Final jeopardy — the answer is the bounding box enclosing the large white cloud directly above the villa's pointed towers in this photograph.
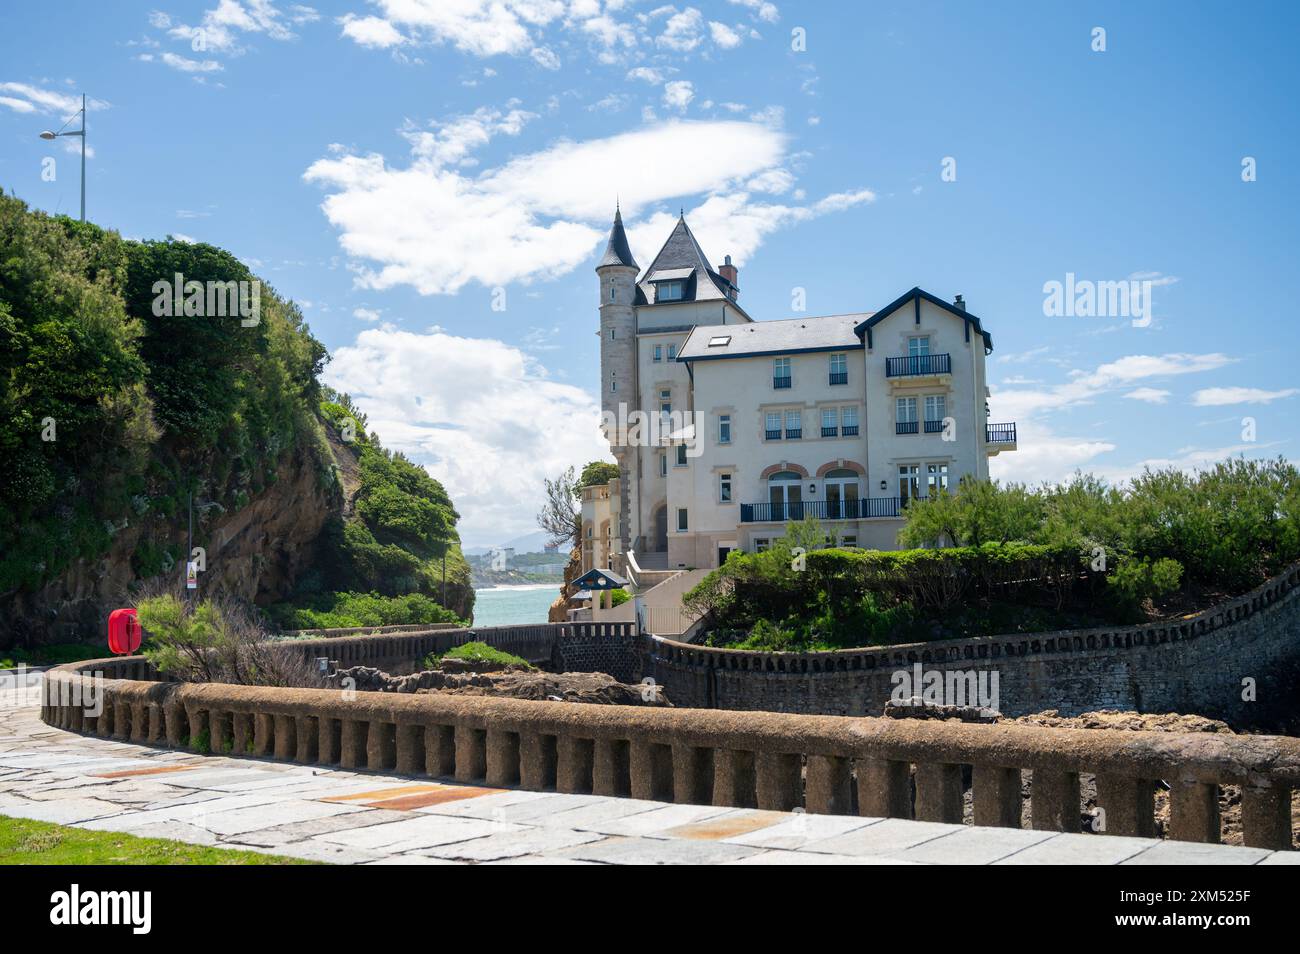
[304,110,875,294]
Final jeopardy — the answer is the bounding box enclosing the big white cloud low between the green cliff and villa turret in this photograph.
[324,328,608,546]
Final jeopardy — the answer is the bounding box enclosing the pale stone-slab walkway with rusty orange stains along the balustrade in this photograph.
[0,689,1300,864]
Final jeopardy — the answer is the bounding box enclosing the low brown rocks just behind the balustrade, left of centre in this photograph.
[326,665,672,706]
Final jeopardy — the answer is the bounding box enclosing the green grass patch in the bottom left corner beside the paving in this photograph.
[0,815,313,864]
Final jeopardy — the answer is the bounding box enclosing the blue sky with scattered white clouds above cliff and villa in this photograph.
[0,0,1300,545]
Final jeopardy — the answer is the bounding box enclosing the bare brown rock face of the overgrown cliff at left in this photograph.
[0,448,330,645]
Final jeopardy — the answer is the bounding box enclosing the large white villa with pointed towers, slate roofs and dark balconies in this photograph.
[582,212,1015,572]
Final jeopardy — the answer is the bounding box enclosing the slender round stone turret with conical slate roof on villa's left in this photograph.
[595,207,641,561]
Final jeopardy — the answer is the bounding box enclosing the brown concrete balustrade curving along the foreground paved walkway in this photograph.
[42,660,1300,849]
